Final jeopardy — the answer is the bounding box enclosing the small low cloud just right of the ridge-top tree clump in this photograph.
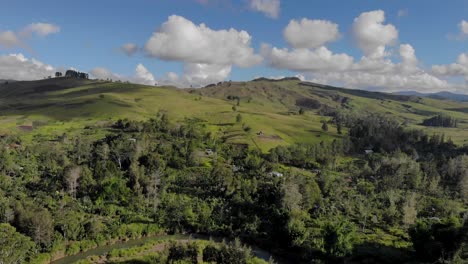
[91,63,156,85]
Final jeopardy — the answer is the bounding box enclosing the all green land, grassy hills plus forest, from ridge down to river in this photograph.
[0,79,468,263]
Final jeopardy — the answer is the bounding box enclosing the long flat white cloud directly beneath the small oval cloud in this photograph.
[262,44,353,71]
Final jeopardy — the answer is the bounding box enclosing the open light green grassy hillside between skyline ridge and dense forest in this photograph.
[0,78,468,151]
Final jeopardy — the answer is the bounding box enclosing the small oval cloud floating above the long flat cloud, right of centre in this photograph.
[283,18,340,48]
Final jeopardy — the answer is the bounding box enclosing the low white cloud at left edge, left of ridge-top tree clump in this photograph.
[0,53,55,81]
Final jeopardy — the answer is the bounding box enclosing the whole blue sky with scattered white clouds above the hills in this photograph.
[0,0,468,93]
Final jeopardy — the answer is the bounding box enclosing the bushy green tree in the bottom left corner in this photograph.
[0,224,35,264]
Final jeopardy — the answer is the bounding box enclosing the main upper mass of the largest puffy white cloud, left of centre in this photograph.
[145,15,261,67]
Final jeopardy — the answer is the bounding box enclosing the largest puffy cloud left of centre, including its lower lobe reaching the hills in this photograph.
[145,15,262,87]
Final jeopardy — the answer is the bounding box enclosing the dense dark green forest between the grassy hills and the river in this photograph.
[0,112,468,263]
